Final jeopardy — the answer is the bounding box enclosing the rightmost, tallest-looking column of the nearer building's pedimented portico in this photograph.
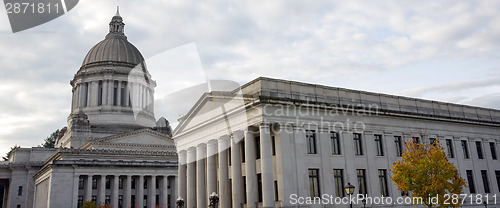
[259,123,274,207]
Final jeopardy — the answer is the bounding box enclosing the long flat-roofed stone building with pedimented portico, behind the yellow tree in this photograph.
[174,78,500,208]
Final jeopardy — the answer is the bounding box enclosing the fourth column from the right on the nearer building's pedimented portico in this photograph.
[218,135,231,208]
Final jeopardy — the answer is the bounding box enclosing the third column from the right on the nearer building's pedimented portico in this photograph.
[231,131,243,207]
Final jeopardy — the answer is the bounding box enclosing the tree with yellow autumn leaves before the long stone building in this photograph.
[391,141,466,208]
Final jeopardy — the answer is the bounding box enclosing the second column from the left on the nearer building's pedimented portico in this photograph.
[185,147,196,207]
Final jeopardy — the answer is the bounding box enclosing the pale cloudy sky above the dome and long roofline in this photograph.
[0,0,500,155]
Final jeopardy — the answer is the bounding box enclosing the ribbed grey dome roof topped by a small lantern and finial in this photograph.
[82,12,144,67]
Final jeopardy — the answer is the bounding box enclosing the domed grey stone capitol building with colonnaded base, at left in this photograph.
[0,11,177,208]
